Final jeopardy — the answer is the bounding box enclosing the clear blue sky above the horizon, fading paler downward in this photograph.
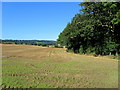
[2,2,81,40]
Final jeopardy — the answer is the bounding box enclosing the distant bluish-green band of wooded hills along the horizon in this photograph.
[0,40,57,46]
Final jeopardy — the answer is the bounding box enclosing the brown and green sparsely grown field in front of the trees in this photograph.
[2,44,118,88]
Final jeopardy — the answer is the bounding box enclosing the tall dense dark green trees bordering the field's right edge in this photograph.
[57,1,120,56]
